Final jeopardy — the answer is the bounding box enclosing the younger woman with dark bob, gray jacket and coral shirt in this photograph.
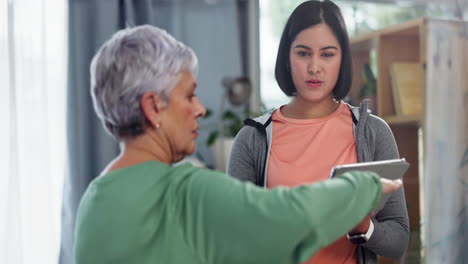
[227,1,409,264]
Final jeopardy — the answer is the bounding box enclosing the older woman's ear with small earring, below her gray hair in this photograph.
[140,92,166,128]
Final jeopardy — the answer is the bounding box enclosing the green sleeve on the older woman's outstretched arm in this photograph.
[177,169,382,264]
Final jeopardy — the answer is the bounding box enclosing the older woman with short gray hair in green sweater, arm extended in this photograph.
[75,25,401,264]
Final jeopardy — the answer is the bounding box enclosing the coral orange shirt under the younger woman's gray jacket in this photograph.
[267,102,357,264]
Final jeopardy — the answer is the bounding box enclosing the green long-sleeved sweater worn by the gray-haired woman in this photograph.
[75,161,382,264]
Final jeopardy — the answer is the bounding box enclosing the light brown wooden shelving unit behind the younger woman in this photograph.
[350,18,466,263]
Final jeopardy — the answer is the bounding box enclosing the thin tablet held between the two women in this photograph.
[330,158,410,211]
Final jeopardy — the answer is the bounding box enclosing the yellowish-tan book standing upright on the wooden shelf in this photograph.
[390,62,424,115]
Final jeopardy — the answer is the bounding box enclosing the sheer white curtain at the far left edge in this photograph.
[0,0,66,264]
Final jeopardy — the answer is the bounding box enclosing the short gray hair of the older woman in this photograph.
[90,25,198,140]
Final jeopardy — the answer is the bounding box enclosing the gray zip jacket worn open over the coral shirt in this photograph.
[227,101,409,264]
